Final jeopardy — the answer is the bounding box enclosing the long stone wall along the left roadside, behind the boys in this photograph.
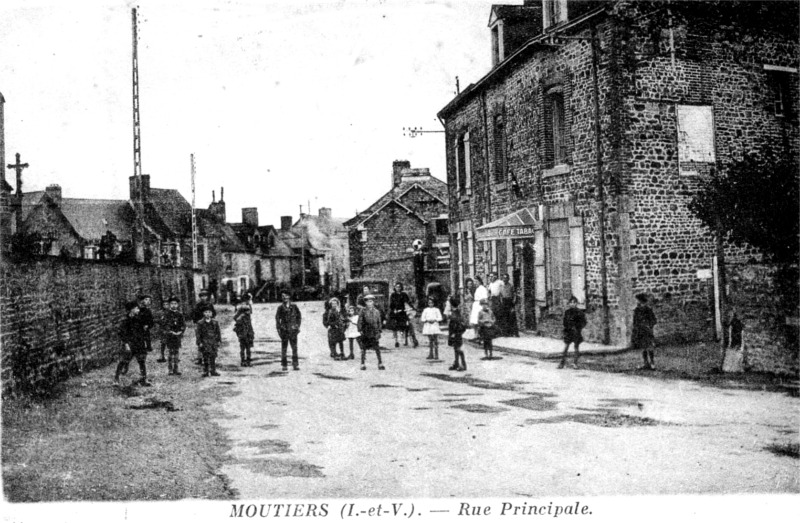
[0,258,194,395]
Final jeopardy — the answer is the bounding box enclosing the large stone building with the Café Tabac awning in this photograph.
[440,0,799,345]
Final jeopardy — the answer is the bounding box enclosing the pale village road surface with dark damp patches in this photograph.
[208,302,800,499]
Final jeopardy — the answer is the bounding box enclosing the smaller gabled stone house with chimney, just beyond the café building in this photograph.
[344,160,450,304]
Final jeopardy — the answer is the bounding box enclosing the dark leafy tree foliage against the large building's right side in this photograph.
[689,149,800,265]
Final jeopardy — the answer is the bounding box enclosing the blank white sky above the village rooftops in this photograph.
[0,0,500,225]
